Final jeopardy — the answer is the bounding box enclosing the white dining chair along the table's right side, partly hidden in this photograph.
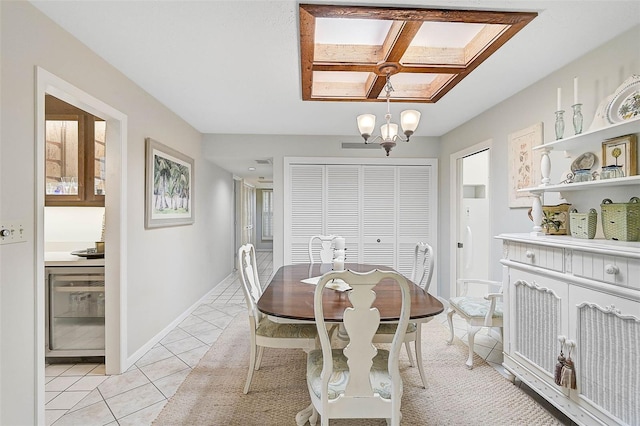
[373,242,434,388]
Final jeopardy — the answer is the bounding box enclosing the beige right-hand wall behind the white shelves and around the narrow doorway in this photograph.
[439,26,640,295]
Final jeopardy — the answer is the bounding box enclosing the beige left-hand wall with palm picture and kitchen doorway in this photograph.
[0,1,233,425]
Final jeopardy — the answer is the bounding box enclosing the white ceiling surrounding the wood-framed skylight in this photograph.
[31,0,640,182]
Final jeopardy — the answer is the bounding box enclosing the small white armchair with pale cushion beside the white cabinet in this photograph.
[447,278,503,369]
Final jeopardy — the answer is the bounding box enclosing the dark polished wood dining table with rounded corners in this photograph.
[257,263,444,426]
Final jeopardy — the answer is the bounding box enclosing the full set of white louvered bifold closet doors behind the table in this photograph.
[285,163,437,276]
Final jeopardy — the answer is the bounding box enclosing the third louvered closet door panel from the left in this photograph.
[361,166,397,268]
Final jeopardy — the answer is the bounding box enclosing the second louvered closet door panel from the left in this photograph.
[325,165,362,262]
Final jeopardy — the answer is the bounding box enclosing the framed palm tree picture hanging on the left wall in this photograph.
[144,138,195,229]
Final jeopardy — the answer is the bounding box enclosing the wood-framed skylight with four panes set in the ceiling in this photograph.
[300,4,537,103]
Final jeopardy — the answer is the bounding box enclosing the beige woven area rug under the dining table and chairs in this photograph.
[153,313,561,426]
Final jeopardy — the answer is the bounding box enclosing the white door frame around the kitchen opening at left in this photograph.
[34,67,128,424]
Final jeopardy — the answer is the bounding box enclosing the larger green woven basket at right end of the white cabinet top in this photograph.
[600,197,640,241]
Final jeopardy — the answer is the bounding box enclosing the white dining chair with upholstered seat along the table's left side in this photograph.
[238,244,318,394]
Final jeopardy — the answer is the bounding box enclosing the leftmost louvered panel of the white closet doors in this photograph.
[285,165,325,264]
